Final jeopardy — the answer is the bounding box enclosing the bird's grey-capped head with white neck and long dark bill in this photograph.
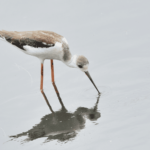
[67,55,100,94]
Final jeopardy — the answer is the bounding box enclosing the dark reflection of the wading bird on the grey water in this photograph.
[10,96,101,142]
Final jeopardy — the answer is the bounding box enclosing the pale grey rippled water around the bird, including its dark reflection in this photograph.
[0,0,150,150]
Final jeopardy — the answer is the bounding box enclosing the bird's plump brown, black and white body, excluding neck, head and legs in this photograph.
[0,30,71,61]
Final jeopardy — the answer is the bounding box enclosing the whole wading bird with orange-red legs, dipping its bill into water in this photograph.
[0,30,100,109]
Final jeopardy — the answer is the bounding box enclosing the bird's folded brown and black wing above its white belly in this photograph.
[0,30,62,50]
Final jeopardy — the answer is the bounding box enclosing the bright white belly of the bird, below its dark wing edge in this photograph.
[24,43,63,60]
